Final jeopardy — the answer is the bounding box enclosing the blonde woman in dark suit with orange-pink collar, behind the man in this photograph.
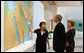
[66,20,75,52]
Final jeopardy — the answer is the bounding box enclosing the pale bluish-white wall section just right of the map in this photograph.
[33,1,45,41]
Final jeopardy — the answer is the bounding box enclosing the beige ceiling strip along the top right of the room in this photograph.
[41,1,83,7]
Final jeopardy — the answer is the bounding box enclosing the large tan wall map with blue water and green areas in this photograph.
[4,1,33,51]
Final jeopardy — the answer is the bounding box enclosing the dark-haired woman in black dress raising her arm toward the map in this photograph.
[27,20,50,52]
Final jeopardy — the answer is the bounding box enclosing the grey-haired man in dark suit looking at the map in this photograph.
[50,15,66,52]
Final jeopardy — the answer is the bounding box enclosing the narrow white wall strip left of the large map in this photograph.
[1,1,4,51]
